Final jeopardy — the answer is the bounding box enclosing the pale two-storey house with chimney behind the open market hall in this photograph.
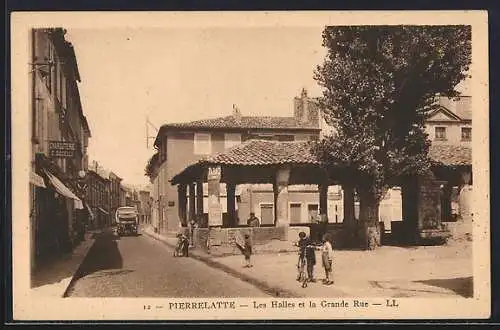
[146,90,320,233]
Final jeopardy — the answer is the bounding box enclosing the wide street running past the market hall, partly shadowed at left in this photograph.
[68,232,266,297]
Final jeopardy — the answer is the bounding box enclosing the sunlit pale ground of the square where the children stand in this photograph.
[144,228,472,298]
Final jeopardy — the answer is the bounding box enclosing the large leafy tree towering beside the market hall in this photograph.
[314,26,471,248]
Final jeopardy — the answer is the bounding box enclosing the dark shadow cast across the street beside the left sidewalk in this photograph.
[74,231,123,281]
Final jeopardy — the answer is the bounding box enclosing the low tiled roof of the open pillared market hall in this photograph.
[199,140,319,166]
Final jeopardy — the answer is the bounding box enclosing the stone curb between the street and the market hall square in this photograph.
[143,230,307,298]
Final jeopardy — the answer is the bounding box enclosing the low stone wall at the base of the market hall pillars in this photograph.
[193,227,309,256]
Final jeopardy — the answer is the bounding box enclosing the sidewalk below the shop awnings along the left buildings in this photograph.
[31,230,101,297]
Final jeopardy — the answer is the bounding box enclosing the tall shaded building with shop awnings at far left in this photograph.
[30,28,91,269]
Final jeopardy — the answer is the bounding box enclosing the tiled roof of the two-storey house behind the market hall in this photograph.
[162,116,319,130]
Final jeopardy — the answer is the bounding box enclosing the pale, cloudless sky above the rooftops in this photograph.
[66,26,326,185]
